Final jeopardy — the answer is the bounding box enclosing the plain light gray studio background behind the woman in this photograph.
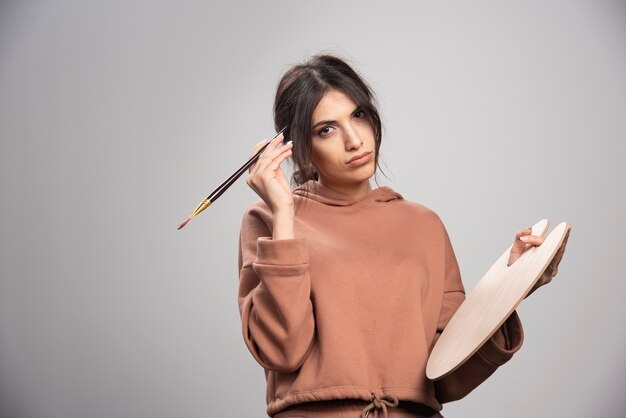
[0,0,626,418]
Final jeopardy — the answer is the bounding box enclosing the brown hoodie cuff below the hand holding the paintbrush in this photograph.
[255,237,309,266]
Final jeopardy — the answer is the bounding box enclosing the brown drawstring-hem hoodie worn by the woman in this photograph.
[239,180,523,416]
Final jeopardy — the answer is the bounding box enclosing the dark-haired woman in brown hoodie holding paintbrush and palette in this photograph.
[238,55,569,418]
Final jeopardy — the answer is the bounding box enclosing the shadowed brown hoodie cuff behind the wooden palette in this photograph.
[478,311,524,366]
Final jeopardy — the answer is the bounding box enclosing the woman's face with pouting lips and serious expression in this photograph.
[311,90,376,190]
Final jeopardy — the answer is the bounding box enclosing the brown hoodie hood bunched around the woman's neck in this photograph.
[293,180,404,206]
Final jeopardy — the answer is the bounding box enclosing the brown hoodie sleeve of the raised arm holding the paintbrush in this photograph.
[238,206,315,373]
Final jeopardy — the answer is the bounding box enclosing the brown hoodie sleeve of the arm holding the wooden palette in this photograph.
[431,220,524,403]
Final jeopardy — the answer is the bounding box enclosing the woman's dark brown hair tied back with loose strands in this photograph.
[274,54,384,189]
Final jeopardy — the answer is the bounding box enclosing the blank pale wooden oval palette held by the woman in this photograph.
[426,219,568,380]
